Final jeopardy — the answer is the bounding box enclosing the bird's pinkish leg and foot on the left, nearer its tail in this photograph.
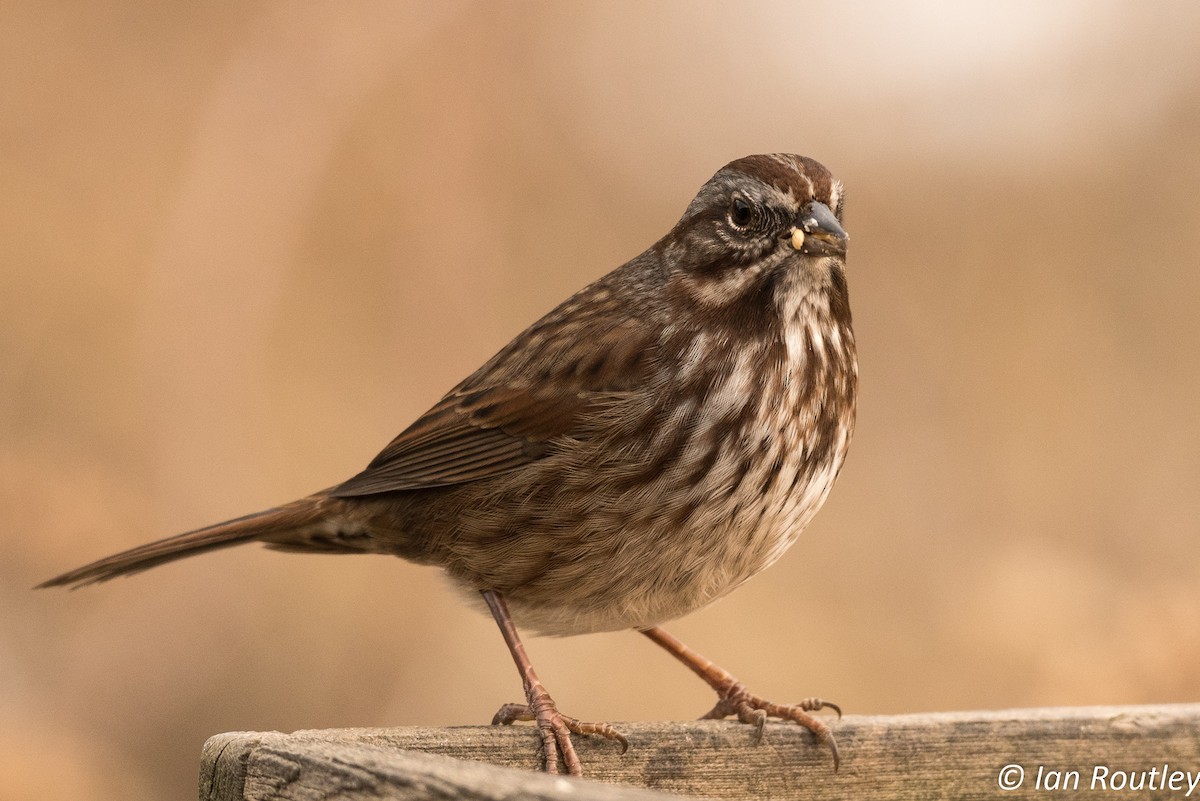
[482,590,629,776]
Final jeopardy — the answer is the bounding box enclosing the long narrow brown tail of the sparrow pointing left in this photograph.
[35,495,326,589]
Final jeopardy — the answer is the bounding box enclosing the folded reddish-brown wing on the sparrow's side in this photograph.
[331,320,650,498]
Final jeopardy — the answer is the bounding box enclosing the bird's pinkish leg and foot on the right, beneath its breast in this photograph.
[640,626,841,771]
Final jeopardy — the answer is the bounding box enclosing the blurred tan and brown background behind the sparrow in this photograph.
[0,0,1200,801]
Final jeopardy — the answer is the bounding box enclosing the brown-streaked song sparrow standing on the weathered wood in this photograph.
[41,155,858,773]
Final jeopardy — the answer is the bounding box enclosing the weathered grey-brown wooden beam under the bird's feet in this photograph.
[200,704,1200,801]
